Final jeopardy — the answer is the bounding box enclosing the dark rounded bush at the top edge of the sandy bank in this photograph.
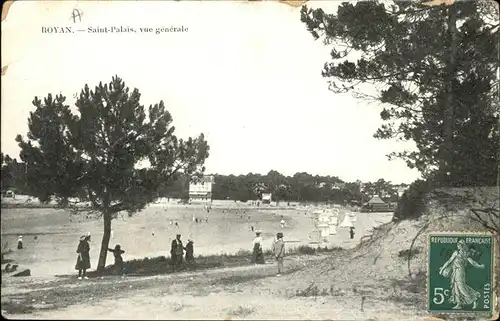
[392,180,430,222]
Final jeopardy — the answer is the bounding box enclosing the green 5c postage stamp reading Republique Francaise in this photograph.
[427,232,496,317]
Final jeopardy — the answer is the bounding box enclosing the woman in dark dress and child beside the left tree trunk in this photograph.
[75,232,125,280]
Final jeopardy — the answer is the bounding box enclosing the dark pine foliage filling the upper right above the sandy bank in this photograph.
[301,0,499,186]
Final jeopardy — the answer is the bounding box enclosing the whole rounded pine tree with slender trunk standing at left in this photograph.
[16,76,209,269]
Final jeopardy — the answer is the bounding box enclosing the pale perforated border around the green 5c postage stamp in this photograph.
[425,231,499,320]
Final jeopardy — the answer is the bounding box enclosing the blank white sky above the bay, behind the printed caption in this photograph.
[1,1,420,183]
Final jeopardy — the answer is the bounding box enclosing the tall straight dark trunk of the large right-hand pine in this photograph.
[439,4,458,183]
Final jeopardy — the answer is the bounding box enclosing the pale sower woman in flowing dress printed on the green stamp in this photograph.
[439,240,484,309]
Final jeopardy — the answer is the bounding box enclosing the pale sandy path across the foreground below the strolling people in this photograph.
[2,256,422,320]
